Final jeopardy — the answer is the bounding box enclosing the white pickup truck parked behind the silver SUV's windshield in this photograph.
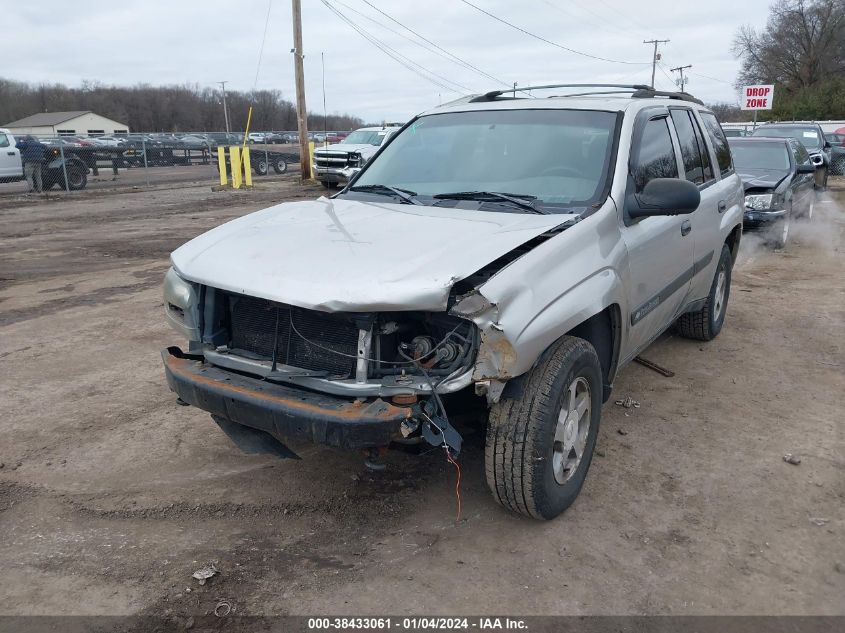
[314,125,400,188]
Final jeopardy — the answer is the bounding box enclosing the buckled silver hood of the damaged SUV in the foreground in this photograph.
[171,198,574,312]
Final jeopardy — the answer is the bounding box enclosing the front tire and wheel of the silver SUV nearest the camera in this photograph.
[485,336,602,520]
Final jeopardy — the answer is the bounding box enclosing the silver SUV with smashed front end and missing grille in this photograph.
[162,85,743,519]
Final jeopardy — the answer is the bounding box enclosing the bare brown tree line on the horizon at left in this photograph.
[0,78,364,132]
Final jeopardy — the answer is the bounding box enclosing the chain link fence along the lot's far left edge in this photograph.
[0,130,310,197]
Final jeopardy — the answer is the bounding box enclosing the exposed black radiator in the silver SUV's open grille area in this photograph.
[228,295,358,378]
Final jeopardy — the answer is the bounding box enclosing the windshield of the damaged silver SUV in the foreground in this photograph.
[355,109,616,210]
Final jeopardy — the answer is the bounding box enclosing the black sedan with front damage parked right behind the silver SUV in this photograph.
[728,137,817,248]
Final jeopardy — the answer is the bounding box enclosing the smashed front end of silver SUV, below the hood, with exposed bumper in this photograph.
[164,269,492,454]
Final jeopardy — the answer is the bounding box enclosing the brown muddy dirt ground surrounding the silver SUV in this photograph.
[0,174,845,617]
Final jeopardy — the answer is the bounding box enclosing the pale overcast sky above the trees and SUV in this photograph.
[8,0,770,121]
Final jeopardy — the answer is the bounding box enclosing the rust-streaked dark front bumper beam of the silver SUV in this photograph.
[161,347,411,449]
